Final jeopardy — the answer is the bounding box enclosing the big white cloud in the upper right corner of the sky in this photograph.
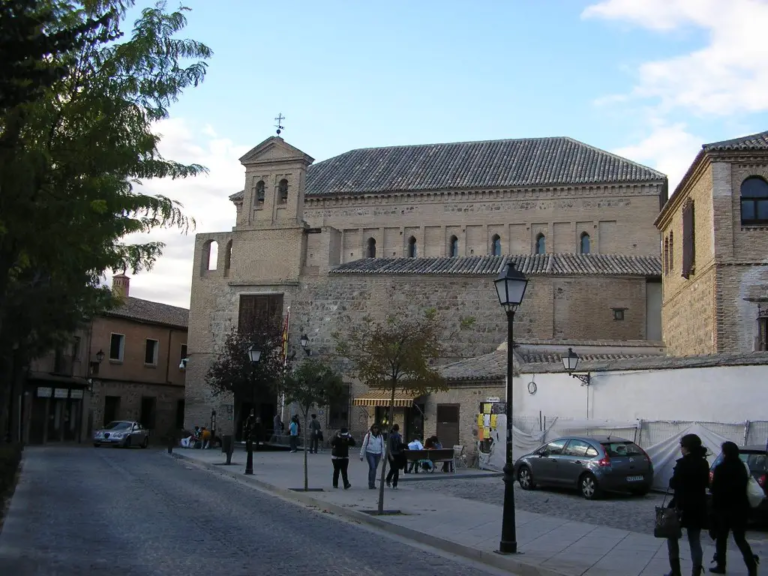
[582,0,768,116]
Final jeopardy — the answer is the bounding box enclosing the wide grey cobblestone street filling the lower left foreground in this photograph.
[0,447,510,576]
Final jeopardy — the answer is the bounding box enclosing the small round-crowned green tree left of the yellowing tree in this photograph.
[281,359,344,491]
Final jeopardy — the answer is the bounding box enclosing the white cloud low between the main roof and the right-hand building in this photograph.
[613,122,701,189]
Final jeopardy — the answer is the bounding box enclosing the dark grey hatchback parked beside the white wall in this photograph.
[515,436,653,500]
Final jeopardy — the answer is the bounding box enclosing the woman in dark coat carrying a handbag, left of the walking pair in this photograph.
[667,434,709,576]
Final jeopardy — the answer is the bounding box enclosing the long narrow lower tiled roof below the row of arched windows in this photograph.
[331,254,661,276]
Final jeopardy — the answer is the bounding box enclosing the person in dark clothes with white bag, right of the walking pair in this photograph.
[710,442,757,576]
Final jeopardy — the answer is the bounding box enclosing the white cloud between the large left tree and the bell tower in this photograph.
[107,118,249,307]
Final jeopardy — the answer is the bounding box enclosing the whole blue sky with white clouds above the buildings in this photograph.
[114,0,768,307]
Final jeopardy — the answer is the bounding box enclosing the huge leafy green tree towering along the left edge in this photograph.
[0,0,211,438]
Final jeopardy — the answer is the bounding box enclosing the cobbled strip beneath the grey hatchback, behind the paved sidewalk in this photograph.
[416,478,768,542]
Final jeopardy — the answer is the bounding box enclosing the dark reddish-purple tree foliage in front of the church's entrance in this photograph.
[205,319,290,403]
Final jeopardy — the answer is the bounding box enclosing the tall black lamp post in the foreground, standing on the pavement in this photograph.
[494,261,528,554]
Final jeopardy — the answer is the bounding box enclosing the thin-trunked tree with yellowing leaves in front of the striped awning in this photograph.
[334,310,464,514]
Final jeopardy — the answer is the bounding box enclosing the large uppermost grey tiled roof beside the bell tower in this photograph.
[230,137,667,201]
